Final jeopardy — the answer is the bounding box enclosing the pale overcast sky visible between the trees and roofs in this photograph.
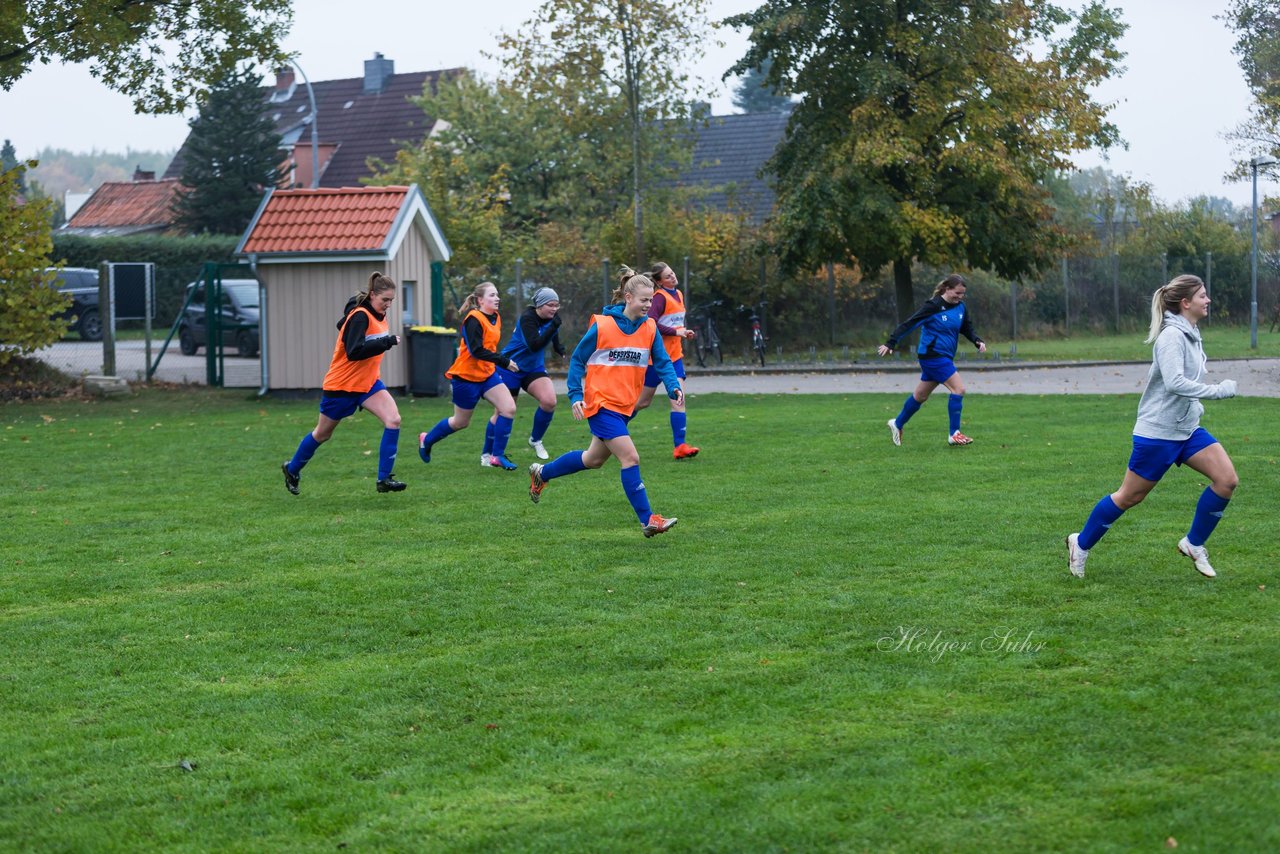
[0,0,1276,205]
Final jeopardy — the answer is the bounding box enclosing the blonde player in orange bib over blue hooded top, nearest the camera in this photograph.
[529,266,684,536]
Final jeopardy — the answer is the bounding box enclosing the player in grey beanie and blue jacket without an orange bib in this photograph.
[480,288,564,467]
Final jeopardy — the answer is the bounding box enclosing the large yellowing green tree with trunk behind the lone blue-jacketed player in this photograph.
[726,0,1124,316]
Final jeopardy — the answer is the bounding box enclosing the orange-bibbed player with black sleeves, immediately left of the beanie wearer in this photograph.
[417,282,520,471]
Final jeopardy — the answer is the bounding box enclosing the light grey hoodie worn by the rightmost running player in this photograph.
[1133,311,1235,442]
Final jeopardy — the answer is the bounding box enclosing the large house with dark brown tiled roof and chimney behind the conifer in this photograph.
[165,54,461,187]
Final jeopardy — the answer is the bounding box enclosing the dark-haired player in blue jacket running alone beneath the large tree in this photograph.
[877,273,987,446]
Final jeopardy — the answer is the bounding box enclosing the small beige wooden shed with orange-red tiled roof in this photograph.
[236,184,449,389]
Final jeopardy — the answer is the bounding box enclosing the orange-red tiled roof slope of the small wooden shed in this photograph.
[239,187,408,255]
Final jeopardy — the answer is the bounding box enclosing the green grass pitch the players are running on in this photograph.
[0,391,1280,851]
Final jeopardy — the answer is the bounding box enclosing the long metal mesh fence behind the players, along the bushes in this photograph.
[444,254,1280,361]
